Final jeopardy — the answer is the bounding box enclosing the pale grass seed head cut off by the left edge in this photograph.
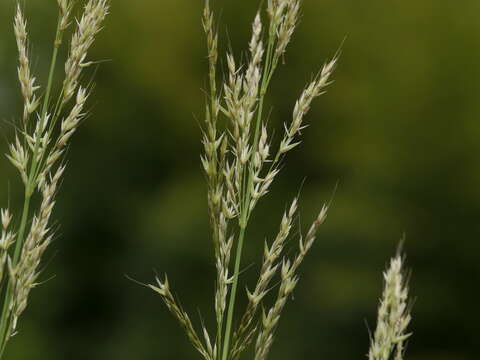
[0,0,109,358]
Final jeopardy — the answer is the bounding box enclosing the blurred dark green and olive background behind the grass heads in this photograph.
[0,0,480,360]
